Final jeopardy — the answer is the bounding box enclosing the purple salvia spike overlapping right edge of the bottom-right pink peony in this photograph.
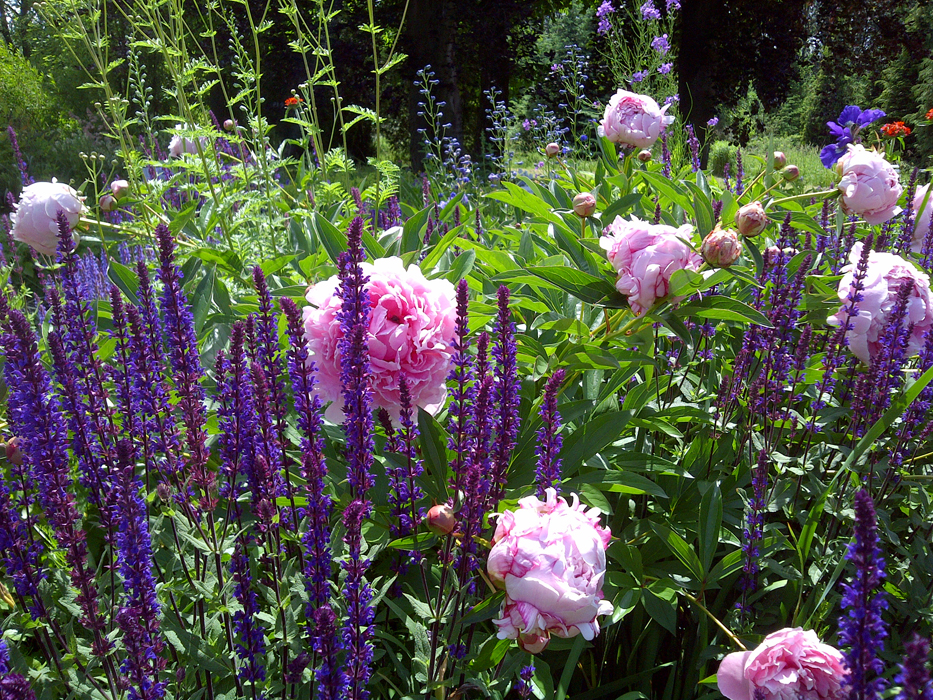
[839,489,888,700]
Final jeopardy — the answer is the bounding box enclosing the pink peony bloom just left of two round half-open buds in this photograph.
[599,216,703,315]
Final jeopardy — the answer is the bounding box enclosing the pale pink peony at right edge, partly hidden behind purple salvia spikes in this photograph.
[827,241,933,364]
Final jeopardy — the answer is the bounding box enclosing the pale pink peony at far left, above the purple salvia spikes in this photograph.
[11,181,84,255]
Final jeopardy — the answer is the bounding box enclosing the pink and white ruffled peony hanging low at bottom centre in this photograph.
[486,488,612,654]
